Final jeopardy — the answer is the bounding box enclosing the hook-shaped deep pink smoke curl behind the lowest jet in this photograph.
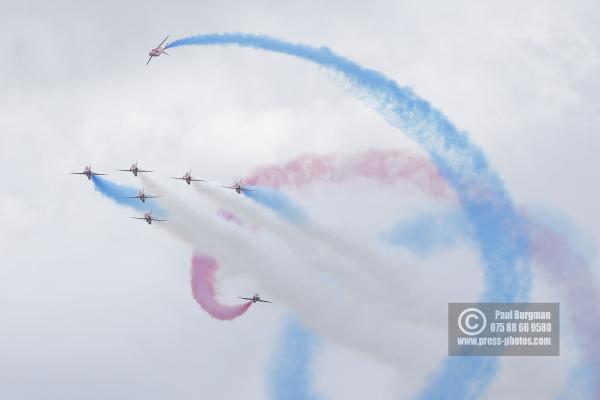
[192,254,252,321]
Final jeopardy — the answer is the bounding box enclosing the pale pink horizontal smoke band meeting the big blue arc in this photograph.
[245,150,454,198]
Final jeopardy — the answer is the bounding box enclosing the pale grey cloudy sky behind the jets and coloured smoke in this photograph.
[0,1,600,399]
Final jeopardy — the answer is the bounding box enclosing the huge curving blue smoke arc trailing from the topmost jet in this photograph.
[167,33,531,399]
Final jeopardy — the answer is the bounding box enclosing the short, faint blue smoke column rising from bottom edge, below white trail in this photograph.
[269,317,318,400]
